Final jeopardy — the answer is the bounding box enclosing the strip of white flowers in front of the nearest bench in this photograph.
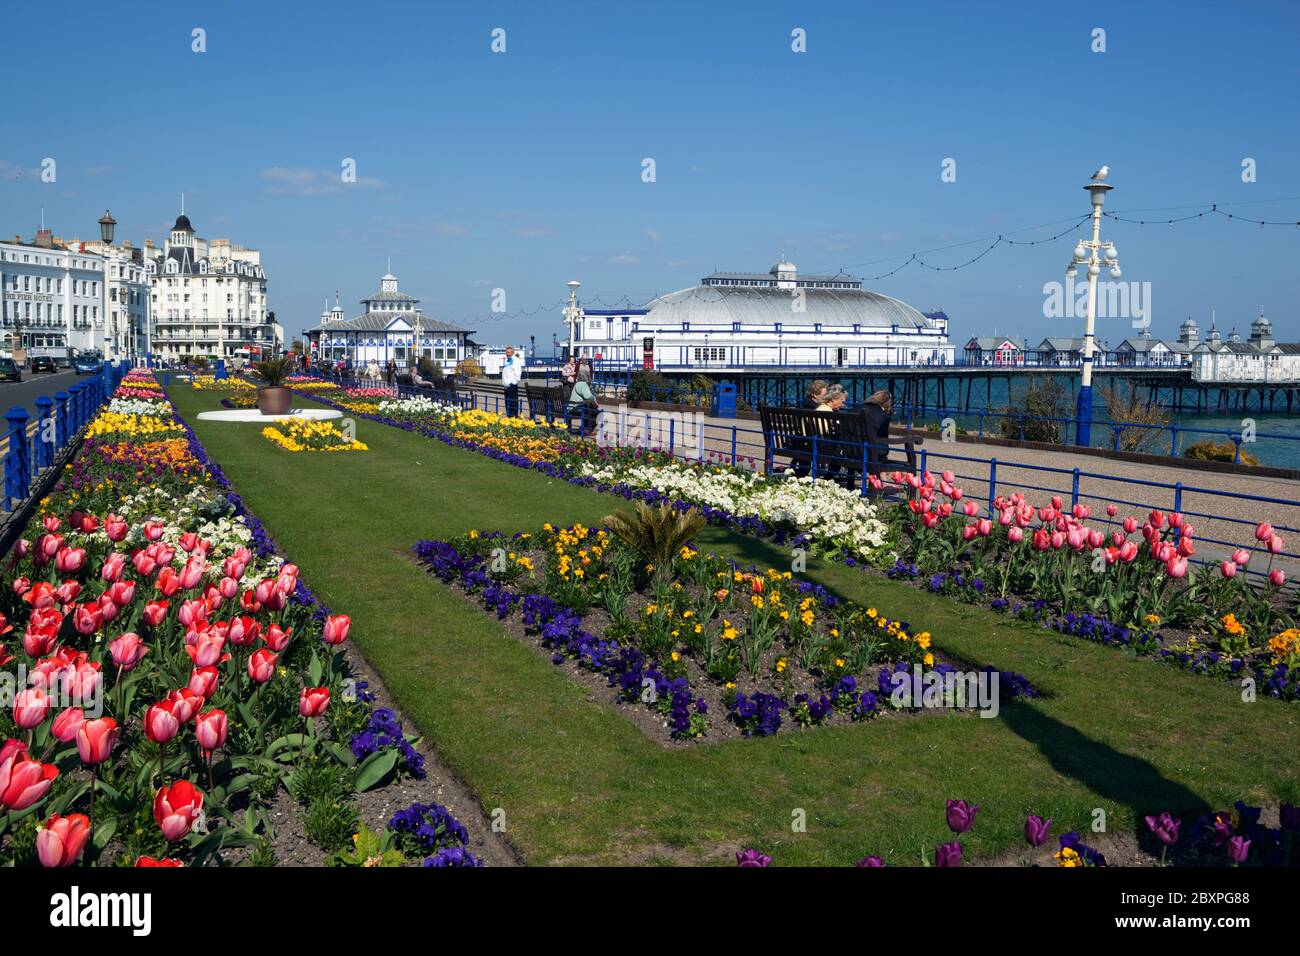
[580,463,888,561]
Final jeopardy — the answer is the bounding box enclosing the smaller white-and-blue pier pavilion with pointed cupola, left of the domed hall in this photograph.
[304,272,472,372]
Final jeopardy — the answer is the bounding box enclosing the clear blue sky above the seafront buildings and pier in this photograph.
[0,0,1300,346]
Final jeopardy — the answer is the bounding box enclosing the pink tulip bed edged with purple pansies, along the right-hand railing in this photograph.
[888,473,1300,700]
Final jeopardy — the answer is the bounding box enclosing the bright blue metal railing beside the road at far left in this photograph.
[3,362,127,512]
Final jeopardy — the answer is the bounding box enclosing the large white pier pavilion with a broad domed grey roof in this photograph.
[564,259,954,371]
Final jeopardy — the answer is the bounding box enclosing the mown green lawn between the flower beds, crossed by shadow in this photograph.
[173,385,1300,865]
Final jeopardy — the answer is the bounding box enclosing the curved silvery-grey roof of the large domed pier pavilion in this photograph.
[642,283,936,332]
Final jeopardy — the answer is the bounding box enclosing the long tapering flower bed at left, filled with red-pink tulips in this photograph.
[0,372,452,866]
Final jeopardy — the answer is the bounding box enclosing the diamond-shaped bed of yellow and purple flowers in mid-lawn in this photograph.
[415,524,1035,740]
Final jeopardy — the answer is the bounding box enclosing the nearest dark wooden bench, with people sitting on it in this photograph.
[758,405,924,492]
